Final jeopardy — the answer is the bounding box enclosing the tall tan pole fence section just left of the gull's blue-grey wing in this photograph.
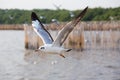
[24,26,43,49]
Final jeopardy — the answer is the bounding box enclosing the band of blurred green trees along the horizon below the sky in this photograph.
[0,7,120,24]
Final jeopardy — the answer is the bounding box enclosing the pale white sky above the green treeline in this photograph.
[0,0,120,10]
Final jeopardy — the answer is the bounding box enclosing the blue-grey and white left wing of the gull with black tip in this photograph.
[31,12,53,44]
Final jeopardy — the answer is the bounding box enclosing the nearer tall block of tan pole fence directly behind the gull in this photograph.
[24,22,84,50]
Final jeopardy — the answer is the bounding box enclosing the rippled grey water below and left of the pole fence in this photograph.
[0,31,120,80]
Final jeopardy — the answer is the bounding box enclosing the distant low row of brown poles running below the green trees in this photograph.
[0,21,120,31]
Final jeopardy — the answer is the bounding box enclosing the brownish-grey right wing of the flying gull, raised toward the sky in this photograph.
[53,7,88,46]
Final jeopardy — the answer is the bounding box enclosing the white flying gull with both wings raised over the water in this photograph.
[31,7,88,58]
